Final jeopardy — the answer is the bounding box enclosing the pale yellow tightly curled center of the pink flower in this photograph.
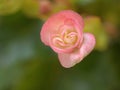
[53,30,78,49]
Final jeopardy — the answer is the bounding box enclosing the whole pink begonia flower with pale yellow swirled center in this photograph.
[40,10,95,68]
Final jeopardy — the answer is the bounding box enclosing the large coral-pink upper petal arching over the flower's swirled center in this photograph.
[40,10,84,45]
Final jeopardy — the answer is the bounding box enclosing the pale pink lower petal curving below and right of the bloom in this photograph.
[58,33,95,68]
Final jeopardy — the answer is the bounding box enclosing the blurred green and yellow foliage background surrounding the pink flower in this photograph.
[0,0,120,90]
